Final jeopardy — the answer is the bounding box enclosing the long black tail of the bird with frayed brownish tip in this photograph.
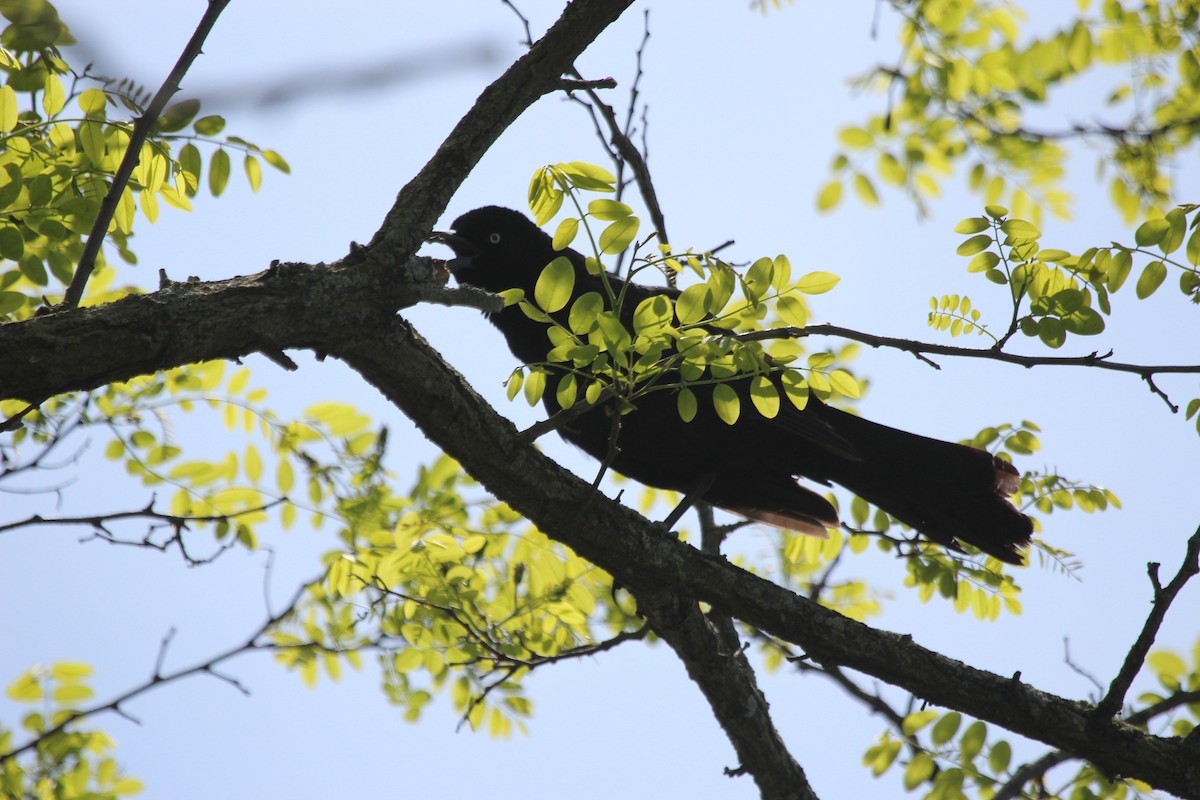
[811,405,1033,564]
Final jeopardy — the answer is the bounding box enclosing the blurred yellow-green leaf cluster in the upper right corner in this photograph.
[817,0,1200,223]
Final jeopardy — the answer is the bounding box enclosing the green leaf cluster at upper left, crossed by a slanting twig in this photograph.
[0,9,289,319]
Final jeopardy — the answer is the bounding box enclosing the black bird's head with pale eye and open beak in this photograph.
[430,205,556,291]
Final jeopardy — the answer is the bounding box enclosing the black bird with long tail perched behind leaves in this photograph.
[431,206,1032,564]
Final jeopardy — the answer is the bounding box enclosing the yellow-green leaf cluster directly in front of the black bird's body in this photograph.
[520,162,862,425]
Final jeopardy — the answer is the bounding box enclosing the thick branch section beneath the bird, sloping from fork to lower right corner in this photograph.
[330,319,1200,798]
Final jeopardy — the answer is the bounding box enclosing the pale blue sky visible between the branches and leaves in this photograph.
[0,0,1200,800]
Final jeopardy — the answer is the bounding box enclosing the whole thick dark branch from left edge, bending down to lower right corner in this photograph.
[0,253,1200,798]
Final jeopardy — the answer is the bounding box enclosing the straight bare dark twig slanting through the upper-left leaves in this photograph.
[59,0,229,309]
